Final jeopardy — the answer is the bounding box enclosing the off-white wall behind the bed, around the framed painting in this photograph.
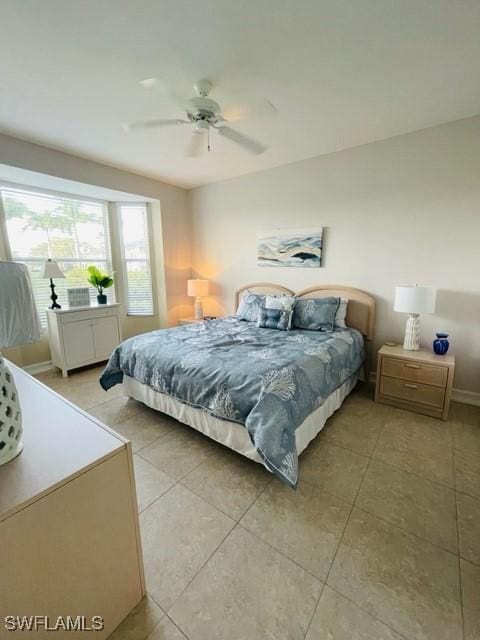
[190,117,480,392]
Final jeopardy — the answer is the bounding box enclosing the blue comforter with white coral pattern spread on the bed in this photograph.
[100,318,364,487]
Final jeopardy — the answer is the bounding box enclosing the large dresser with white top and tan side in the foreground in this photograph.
[0,363,145,640]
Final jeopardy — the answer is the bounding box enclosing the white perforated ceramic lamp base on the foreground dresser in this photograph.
[0,355,23,466]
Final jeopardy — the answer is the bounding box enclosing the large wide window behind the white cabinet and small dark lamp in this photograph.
[0,187,113,326]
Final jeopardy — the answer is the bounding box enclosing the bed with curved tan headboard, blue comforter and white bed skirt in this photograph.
[100,283,375,487]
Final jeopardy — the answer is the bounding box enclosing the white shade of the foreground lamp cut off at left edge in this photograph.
[0,261,41,348]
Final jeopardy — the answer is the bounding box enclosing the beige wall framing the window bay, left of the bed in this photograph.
[0,134,192,366]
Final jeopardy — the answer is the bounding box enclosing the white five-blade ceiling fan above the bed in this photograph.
[124,80,276,156]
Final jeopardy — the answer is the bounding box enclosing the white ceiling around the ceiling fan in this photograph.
[0,0,480,187]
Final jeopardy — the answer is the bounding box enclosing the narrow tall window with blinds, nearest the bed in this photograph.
[118,203,153,316]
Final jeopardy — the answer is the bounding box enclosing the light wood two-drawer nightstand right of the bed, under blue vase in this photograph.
[375,345,455,420]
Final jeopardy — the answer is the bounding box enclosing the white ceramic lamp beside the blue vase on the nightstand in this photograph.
[393,285,437,351]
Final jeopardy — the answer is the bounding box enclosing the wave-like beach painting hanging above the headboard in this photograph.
[257,227,323,267]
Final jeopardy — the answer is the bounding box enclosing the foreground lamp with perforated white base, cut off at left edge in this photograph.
[0,261,41,465]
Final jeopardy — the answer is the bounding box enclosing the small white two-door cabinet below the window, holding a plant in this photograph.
[47,304,122,378]
